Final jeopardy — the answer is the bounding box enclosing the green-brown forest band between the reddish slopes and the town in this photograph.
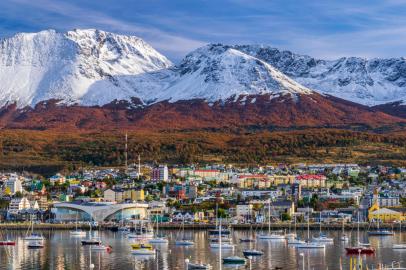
[0,129,406,173]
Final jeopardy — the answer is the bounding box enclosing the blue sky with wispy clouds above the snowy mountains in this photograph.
[0,0,406,62]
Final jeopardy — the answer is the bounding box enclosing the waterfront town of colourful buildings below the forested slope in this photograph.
[0,163,406,229]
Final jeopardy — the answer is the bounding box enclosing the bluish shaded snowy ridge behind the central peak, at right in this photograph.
[234,45,406,106]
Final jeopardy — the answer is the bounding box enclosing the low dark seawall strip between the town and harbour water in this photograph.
[0,223,399,231]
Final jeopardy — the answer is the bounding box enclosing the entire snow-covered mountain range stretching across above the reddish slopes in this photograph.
[0,29,406,108]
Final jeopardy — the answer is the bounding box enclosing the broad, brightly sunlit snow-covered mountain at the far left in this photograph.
[0,29,172,107]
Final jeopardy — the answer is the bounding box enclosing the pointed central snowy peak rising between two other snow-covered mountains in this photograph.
[128,45,313,102]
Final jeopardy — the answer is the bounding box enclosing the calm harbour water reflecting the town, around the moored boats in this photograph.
[0,231,406,270]
